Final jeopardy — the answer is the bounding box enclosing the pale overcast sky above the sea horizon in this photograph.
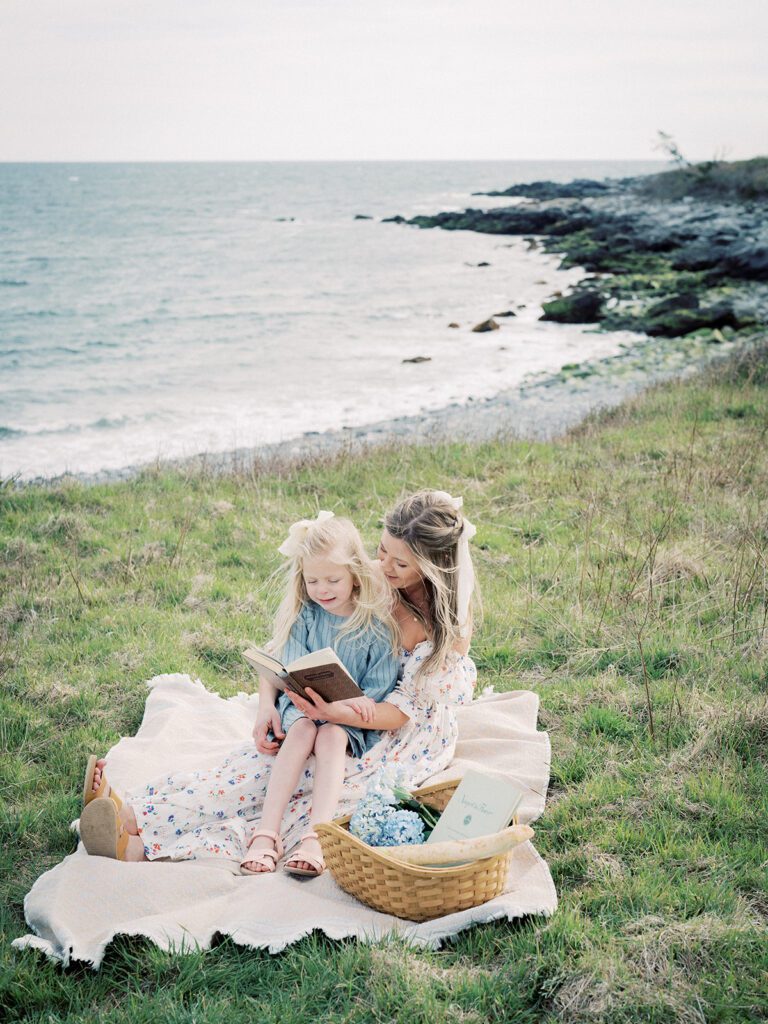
[0,0,768,161]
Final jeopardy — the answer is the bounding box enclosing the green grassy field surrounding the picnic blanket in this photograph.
[0,350,768,1024]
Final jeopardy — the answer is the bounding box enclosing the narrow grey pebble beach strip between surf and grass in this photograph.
[34,327,744,486]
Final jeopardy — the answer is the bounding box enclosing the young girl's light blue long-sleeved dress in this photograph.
[278,602,398,758]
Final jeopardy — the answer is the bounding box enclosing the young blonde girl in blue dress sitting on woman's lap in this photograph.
[241,512,397,876]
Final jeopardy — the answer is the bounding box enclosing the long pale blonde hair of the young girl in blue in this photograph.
[270,516,397,652]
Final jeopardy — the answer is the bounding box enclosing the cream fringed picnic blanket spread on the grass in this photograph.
[13,675,557,968]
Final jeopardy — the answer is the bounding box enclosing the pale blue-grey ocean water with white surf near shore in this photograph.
[0,161,659,479]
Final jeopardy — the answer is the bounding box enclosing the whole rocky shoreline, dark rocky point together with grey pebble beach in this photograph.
[18,160,768,486]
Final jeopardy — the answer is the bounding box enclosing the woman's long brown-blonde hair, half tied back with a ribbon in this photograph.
[384,490,477,675]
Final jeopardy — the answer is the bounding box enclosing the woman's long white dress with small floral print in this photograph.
[126,640,477,863]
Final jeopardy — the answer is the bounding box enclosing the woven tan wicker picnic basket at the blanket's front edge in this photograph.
[315,779,520,921]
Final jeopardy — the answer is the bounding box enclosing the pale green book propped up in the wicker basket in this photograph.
[427,770,522,843]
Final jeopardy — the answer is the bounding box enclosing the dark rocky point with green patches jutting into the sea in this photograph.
[386,158,768,342]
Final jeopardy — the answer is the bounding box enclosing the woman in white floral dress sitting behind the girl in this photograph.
[83,490,476,873]
